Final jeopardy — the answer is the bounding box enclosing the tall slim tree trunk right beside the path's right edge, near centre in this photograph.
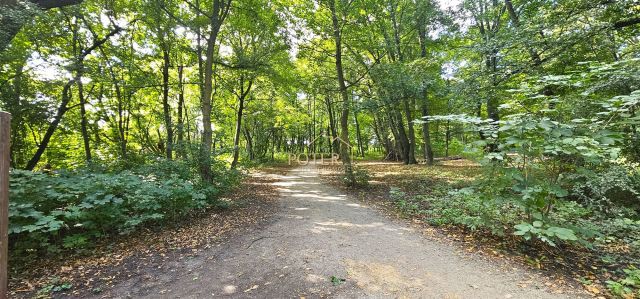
[329,0,356,185]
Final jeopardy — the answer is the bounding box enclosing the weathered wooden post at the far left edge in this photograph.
[0,111,11,299]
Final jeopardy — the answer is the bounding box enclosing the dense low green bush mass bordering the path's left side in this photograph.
[9,161,239,252]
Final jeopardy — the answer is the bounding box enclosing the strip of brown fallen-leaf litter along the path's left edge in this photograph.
[9,168,284,298]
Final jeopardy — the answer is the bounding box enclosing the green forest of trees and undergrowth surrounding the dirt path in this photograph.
[0,0,640,298]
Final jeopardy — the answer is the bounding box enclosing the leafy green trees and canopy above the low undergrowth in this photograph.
[0,0,640,296]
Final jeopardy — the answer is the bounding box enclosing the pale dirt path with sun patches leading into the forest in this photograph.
[99,166,575,298]
